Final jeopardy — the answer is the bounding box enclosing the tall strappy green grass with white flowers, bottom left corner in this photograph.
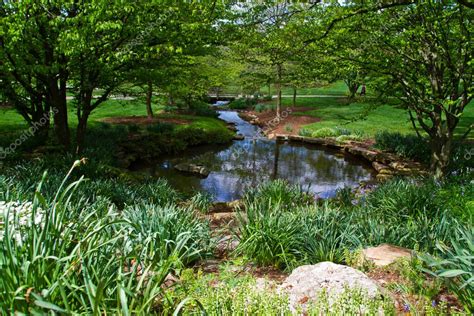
[0,164,210,315]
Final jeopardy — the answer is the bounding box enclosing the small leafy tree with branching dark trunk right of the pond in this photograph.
[320,1,474,178]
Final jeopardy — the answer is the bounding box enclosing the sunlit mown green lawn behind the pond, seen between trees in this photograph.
[0,93,474,139]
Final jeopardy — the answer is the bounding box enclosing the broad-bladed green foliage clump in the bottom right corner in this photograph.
[421,227,474,313]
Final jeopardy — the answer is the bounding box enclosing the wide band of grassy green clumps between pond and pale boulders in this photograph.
[237,180,466,269]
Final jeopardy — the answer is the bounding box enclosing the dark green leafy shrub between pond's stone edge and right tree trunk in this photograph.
[375,131,431,163]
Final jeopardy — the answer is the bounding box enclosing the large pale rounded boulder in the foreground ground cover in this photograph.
[281,262,379,310]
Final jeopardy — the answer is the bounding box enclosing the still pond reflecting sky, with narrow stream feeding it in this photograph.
[131,111,374,201]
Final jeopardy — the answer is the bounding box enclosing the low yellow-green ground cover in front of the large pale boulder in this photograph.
[163,262,394,316]
